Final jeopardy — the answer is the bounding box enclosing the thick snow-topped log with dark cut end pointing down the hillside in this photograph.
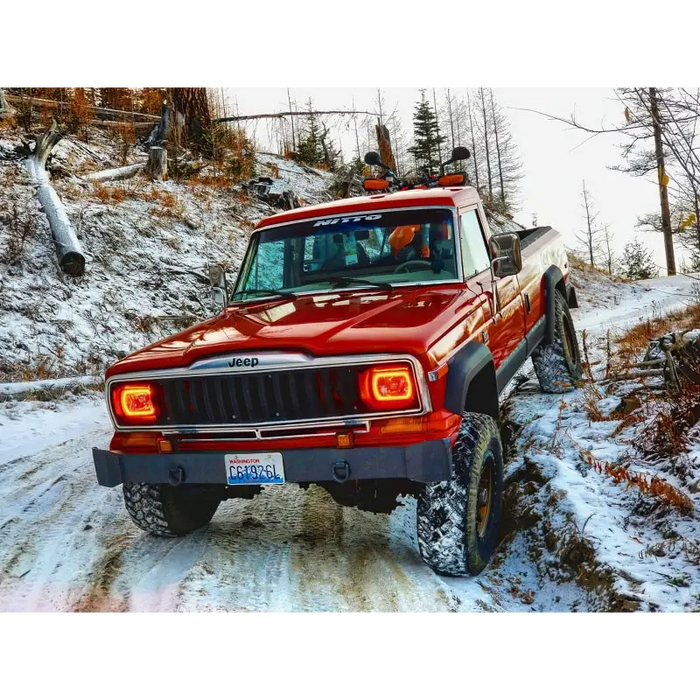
[25,120,85,277]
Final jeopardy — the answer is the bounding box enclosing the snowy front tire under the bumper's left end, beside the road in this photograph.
[123,483,222,537]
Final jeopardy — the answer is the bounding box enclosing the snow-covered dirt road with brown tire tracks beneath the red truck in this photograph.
[0,278,692,614]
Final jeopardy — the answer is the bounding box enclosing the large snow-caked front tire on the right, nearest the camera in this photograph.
[417,413,503,576]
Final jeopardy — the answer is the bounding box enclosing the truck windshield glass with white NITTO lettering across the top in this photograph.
[236,209,458,299]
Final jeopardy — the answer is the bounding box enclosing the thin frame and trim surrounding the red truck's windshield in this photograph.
[232,204,465,303]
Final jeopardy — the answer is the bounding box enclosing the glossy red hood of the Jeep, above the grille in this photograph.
[107,285,479,377]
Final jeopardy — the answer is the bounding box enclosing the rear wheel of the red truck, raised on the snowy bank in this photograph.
[532,290,583,394]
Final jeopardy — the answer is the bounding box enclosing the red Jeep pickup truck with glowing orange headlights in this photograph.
[94,152,581,575]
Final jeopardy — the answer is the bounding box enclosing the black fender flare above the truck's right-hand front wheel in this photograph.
[445,340,498,419]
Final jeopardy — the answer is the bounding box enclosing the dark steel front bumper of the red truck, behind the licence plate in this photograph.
[92,439,452,486]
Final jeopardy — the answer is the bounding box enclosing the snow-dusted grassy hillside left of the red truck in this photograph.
[0,132,333,382]
